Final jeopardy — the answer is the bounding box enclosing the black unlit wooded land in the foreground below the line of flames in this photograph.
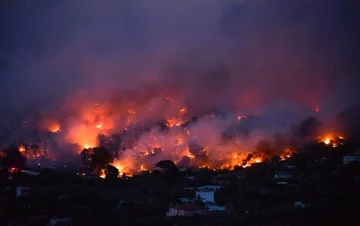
[0,146,360,226]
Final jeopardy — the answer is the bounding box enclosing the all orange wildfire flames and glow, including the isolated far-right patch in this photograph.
[15,96,344,177]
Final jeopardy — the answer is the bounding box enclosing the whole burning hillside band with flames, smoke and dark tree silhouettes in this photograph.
[0,92,343,175]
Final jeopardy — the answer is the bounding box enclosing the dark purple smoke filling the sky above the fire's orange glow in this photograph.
[0,0,360,119]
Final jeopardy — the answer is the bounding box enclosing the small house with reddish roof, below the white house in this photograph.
[166,203,206,217]
